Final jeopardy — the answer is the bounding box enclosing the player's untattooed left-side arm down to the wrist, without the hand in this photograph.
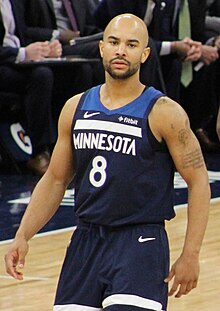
[16,98,76,240]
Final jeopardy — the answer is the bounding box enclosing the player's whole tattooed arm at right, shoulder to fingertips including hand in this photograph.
[150,97,210,297]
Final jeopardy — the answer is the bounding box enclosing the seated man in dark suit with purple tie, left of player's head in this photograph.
[23,0,104,84]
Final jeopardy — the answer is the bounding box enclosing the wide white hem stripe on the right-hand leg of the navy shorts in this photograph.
[102,294,162,311]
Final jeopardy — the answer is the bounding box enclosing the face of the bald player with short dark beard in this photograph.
[100,15,150,80]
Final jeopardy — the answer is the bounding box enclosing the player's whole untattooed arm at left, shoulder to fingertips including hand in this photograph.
[5,96,79,280]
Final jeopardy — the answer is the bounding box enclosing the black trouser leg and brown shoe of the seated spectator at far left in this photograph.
[0,64,55,176]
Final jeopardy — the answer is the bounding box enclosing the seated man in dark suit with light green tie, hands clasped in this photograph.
[156,0,219,151]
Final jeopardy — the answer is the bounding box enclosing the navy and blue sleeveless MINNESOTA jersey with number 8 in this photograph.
[72,86,175,227]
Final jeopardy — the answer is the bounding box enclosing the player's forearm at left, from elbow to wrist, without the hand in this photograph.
[16,174,66,241]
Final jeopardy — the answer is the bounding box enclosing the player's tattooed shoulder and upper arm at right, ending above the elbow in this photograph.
[149,97,205,172]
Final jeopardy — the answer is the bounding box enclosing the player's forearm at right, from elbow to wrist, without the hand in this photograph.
[183,179,210,256]
